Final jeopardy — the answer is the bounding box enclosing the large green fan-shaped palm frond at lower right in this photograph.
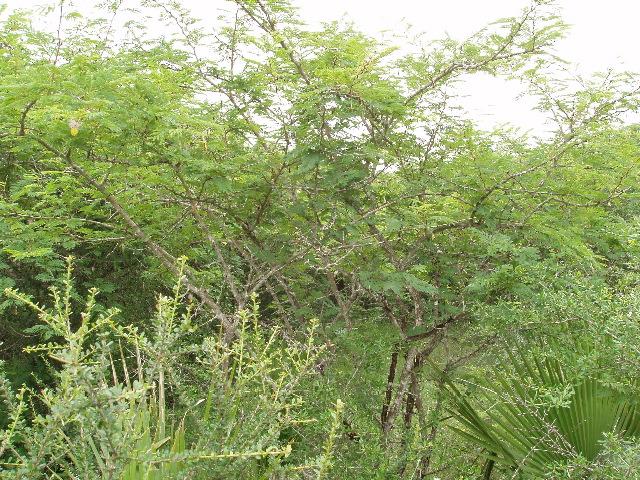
[444,351,640,478]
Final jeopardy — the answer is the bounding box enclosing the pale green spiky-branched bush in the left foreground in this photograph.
[0,265,341,480]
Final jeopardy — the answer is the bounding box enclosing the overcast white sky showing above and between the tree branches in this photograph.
[5,0,640,134]
